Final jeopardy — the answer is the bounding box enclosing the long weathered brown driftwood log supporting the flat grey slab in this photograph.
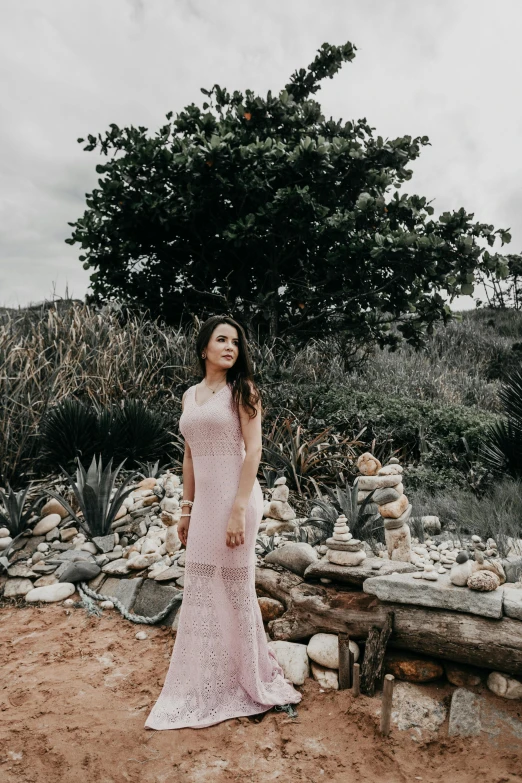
[256,568,522,675]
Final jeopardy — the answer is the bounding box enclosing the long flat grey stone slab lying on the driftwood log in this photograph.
[363,573,503,617]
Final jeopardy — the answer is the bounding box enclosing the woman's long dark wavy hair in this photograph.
[196,315,263,419]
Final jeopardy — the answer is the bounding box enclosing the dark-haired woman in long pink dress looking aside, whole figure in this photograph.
[145,315,301,729]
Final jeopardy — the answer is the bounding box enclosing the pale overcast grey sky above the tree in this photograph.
[0,0,522,307]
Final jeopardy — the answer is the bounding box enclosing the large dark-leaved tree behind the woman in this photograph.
[65,43,510,346]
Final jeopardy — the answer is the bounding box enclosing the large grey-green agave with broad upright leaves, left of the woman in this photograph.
[45,455,136,538]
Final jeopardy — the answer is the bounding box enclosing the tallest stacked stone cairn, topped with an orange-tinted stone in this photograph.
[356,452,412,563]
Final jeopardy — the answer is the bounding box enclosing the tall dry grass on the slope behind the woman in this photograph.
[0,301,522,484]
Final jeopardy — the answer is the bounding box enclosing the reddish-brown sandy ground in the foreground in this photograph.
[0,594,522,783]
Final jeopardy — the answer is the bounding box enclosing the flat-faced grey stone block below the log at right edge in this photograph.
[448,688,522,751]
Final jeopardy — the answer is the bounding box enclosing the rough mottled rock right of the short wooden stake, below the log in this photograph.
[391,681,447,736]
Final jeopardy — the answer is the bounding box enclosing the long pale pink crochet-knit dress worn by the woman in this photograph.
[145,384,302,729]
